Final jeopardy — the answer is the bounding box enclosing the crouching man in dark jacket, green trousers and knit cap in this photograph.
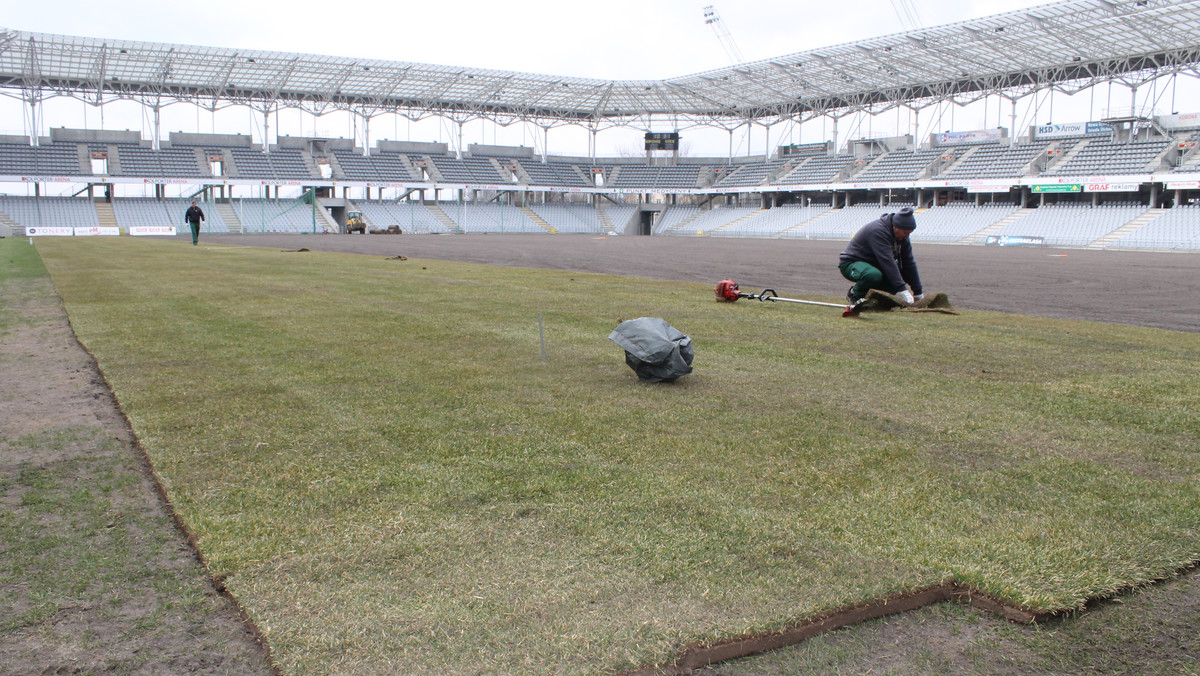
[838,207,925,305]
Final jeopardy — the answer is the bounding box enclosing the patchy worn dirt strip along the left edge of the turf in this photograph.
[0,267,274,676]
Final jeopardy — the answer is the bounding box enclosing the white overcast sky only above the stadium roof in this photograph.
[11,0,1060,79]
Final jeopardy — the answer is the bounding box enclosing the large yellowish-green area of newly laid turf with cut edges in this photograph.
[37,238,1200,674]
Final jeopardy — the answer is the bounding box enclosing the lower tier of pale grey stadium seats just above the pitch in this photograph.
[0,196,1200,250]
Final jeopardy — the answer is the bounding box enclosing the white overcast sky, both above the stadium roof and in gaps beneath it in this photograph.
[0,0,1198,156]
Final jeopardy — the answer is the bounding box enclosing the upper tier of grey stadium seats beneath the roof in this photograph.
[0,133,1200,186]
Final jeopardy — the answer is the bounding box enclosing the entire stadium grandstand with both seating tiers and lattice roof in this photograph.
[0,0,1200,251]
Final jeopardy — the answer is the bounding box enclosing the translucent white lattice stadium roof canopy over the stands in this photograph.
[0,0,1200,126]
